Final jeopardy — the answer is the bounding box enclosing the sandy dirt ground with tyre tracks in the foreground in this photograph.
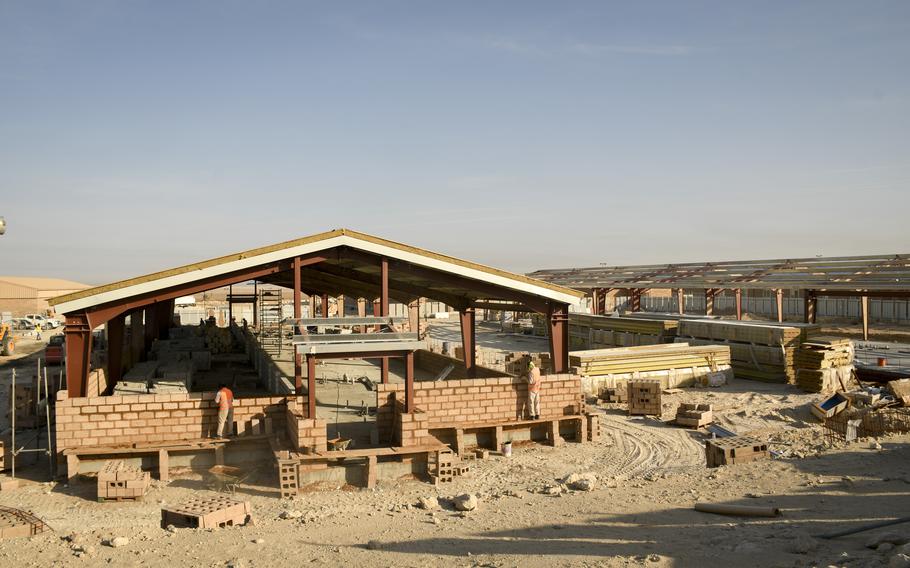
[0,326,910,568]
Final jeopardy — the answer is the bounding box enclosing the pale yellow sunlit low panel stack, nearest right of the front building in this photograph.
[569,343,733,394]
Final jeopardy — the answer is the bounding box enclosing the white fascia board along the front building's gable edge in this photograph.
[55,235,578,314]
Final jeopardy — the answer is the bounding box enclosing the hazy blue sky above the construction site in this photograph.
[0,0,910,284]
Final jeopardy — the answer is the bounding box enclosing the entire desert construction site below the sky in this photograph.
[0,229,910,566]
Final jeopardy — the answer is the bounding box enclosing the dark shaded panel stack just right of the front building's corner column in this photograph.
[569,313,679,349]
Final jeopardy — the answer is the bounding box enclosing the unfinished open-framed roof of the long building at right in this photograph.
[528,254,910,292]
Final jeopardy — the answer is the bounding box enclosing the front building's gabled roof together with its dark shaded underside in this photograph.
[51,229,582,313]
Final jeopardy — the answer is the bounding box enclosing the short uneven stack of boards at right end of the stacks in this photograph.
[796,335,854,393]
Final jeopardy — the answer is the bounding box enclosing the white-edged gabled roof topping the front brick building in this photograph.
[50,229,583,313]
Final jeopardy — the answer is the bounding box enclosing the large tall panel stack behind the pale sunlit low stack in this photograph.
[676,320,820,383]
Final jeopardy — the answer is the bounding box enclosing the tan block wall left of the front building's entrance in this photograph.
[56,391,306,451]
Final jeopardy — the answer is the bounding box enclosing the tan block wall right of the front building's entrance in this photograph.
[376,374,584,439]
